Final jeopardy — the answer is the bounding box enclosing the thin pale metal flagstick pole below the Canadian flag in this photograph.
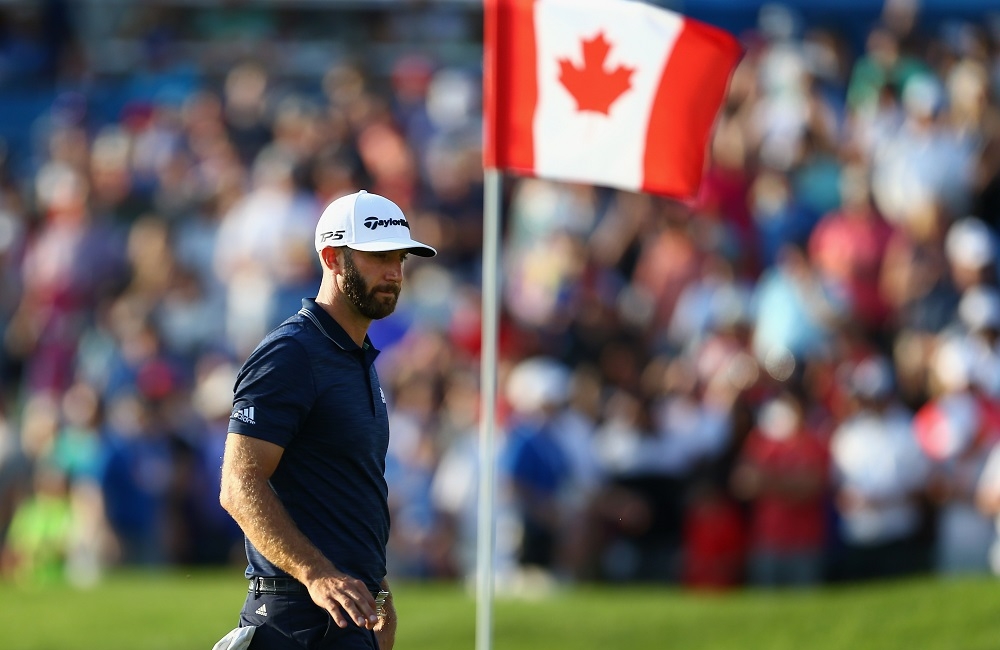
[476,169,502,650]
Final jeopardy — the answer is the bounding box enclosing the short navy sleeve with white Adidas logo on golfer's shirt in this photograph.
[229,337,315,447]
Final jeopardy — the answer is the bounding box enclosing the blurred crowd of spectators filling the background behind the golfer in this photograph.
[0,2,1000,590]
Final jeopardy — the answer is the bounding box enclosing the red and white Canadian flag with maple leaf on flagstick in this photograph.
[483,0,743,199]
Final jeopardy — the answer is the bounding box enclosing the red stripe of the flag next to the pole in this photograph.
[483,0,538,175]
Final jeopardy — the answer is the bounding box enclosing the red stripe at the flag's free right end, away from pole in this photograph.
[642,20,743,199]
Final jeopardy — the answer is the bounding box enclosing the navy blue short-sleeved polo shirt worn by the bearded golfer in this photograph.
[229,299,389,590]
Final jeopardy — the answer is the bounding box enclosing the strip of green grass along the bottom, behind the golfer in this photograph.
[0,569,1000,650]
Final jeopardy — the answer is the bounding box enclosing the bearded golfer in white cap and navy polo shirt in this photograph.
[216,191,436,650]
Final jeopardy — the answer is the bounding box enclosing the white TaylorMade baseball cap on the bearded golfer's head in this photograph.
[316,190,437,257]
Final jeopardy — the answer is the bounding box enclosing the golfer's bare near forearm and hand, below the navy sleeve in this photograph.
[219,433,378,630]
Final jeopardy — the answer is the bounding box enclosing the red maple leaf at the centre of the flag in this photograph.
[559,32,635,115]
